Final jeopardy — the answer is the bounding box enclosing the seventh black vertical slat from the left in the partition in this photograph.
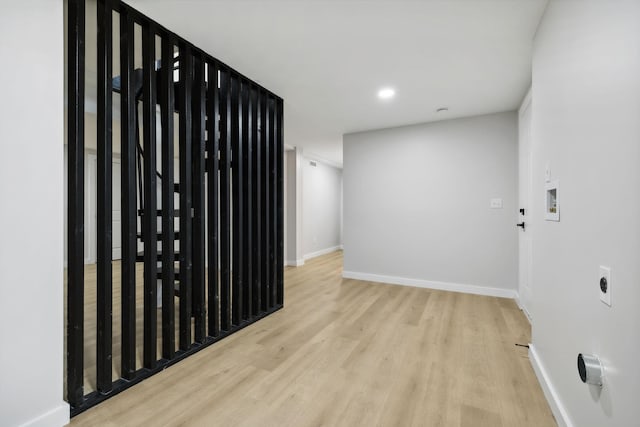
[192,58,206,343]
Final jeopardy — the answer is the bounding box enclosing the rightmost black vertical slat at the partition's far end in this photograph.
[268,97,280,308]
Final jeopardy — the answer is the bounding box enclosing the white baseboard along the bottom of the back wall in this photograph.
[342,271,516,299]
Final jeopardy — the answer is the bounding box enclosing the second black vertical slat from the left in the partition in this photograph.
[96,0,113,393]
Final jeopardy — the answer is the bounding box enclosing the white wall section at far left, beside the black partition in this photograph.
[0,0,69,426]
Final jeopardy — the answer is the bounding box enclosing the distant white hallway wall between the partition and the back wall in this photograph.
[301,157,342,258]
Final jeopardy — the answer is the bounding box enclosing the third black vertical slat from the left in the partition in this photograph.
[120,9,138,380]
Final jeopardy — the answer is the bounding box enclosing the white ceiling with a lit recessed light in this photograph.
[127,0,547,164]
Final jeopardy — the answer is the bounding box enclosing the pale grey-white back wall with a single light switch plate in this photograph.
[344,112,518,296]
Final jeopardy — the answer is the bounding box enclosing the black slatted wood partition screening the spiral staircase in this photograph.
[66,0,284,415]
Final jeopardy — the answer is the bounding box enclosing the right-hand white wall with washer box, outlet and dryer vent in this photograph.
[532,1,640,427]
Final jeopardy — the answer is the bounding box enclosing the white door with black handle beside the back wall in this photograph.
[518,93,533,319]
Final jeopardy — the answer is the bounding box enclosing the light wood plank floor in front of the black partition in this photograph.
[71,252,556,427]
